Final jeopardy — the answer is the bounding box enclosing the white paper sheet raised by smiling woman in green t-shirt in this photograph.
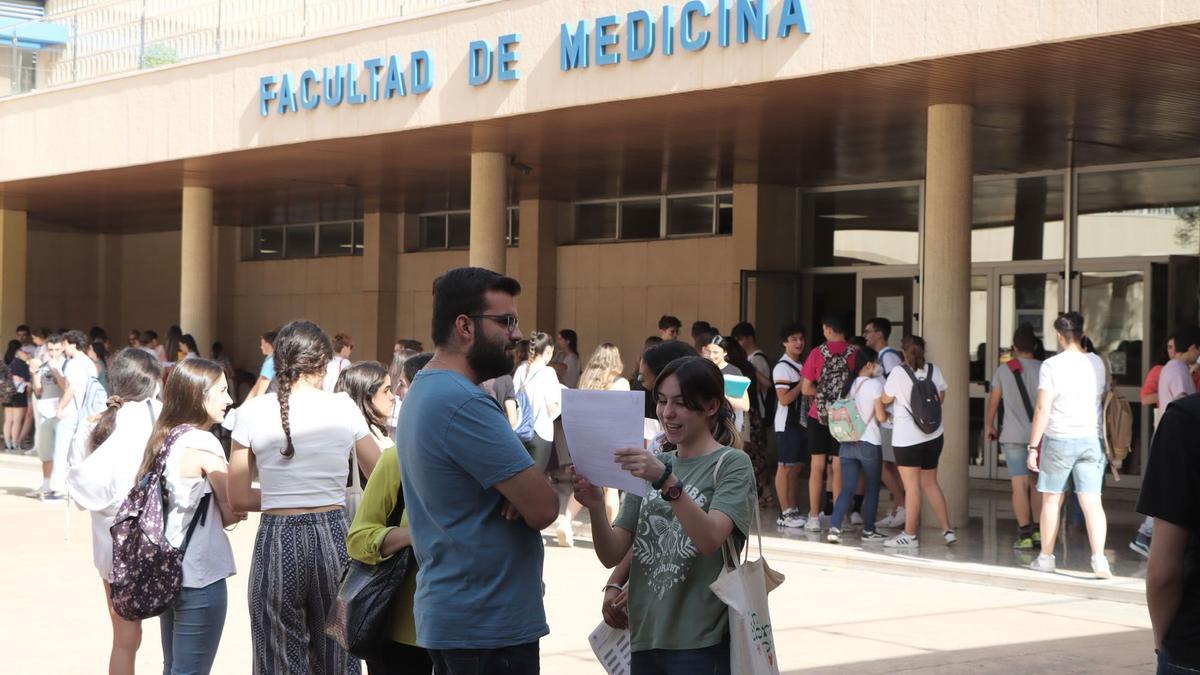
[563,389,646,497]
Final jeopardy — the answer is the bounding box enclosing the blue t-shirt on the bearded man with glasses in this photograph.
[396,370,550,650]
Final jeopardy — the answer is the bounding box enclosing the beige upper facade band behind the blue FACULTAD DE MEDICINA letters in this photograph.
[0,0,1200,183]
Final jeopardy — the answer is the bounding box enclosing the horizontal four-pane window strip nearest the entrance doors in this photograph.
[575,192,733,241]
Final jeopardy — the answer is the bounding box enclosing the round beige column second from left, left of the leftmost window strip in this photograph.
[179,185,216,354]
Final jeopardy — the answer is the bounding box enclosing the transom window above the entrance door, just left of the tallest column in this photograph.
[803,185,920,267]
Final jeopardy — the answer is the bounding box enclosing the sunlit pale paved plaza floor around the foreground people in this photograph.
[0,455,1153,675]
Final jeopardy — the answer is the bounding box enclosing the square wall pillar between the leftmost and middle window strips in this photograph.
[355,211,402,365]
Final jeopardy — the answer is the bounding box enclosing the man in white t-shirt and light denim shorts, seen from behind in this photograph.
[1028,312,1112,579]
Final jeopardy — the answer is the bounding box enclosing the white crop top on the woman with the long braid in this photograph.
[233,390,370,510]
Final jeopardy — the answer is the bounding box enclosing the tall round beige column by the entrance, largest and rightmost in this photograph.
[920,103,972,527]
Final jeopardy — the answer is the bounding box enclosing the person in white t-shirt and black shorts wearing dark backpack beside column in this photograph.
[880,335,958,549]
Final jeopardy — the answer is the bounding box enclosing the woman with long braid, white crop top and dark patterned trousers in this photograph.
[229,321,379,675]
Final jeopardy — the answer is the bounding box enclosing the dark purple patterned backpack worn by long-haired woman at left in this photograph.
[109,424,211,621]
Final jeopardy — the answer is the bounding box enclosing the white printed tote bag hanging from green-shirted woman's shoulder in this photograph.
[708,498,784,675]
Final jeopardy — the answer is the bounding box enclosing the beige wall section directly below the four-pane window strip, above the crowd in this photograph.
[554,237,739,372]
